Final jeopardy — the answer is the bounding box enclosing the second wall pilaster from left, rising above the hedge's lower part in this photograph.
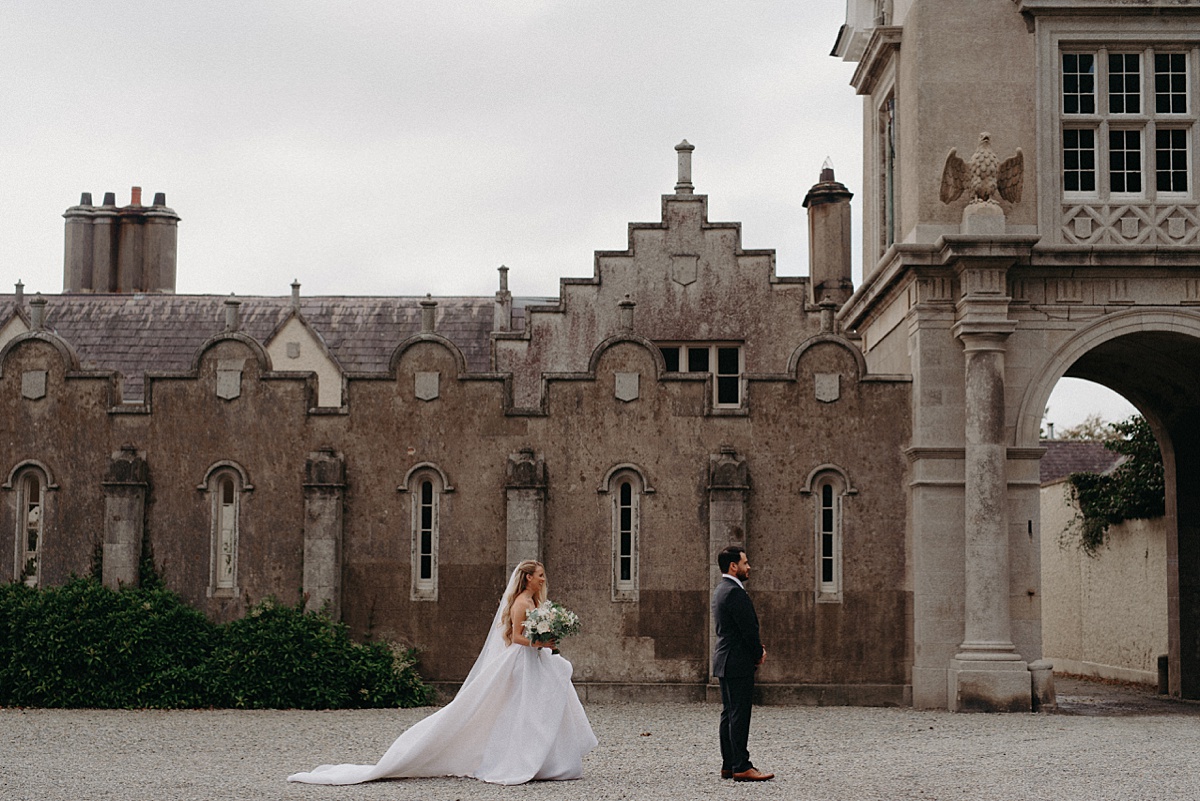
[302,447,346,620]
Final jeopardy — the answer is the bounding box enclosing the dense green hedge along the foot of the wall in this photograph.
[0,578,432,709]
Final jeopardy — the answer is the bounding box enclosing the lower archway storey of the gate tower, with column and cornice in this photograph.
[839,235,1200,710]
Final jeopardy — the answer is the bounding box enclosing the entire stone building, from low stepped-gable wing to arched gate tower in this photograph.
[7,0,1200,710]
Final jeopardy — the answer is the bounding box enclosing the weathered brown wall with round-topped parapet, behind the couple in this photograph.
[0,306,908,693]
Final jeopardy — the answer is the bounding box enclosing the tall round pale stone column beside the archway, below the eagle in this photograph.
[947,265,1032,711]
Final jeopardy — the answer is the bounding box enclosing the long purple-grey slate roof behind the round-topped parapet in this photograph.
[0,294,546,401]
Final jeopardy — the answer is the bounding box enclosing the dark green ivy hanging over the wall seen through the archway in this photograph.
[1063,415,1166,556]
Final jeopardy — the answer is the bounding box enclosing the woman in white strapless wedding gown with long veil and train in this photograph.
[288,560,596,784]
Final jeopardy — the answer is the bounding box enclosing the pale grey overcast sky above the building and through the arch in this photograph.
[0,0,1137,426]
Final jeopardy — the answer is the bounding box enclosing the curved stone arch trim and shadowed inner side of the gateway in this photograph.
[1016,311,1200,698]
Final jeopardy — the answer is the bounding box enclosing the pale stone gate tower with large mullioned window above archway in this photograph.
[835,0,1200,710]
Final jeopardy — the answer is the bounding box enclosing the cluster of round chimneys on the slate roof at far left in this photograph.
[62,186,179,293]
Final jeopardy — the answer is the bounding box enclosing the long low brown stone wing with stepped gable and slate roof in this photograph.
[0,159,911,704]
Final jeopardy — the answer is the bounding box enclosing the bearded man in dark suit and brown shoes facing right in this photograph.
[713,546,775,782]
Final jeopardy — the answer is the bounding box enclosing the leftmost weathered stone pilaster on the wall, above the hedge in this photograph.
[101,445,150,590]
